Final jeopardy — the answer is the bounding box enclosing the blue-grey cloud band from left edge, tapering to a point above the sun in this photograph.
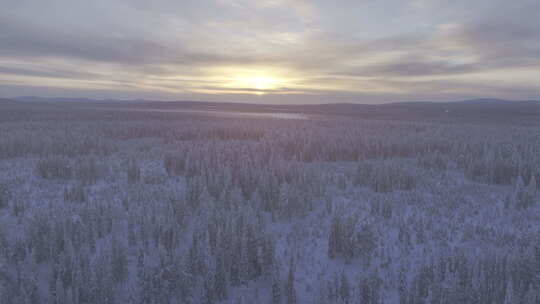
[0,13,272,65]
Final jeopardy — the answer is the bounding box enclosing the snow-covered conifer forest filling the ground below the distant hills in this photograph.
[0,105,540,304]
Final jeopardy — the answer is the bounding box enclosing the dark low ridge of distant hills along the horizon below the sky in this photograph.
[7,96,540,125]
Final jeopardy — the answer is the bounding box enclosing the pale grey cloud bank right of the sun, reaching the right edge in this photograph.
[320,20,540,77]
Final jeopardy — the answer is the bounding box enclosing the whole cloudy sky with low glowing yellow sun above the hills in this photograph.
[0,0,540,104]
